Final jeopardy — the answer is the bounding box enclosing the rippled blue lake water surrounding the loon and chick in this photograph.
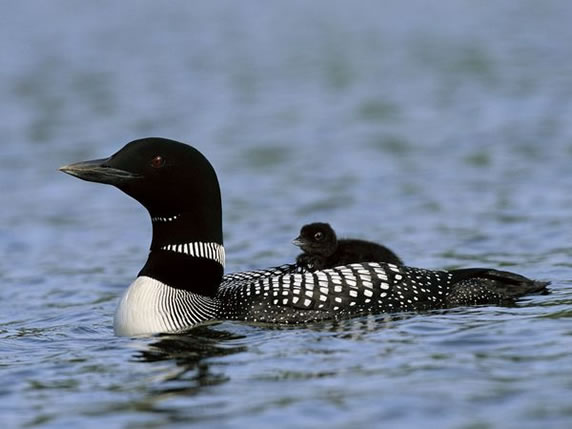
[0,0,572,429]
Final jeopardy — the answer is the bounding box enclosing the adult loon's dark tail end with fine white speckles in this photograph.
[447,268,550,307]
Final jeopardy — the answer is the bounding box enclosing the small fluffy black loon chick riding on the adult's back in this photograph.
[292,222,403,271]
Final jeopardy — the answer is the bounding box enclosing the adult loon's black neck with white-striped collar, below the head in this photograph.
[139,210,224,296]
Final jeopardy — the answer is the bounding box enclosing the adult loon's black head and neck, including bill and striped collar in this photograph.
[60,137,224,295]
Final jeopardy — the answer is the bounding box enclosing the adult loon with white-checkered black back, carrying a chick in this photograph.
[60,138,547,336]
